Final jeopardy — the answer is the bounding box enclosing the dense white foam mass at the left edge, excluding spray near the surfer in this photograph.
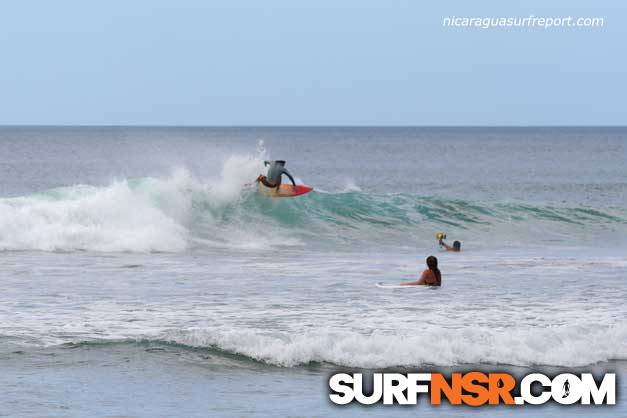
[0,174,189,252]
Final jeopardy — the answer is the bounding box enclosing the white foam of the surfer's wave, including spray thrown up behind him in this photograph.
[0,149,263,252]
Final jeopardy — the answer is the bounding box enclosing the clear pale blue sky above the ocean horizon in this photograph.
[0,0,627,126]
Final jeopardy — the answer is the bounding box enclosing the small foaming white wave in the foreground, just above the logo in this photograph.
[162,325,627,368]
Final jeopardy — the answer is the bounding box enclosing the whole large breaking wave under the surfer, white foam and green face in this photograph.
[0,153,627,252]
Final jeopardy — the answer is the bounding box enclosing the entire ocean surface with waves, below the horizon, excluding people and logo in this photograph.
[0,126,627,417]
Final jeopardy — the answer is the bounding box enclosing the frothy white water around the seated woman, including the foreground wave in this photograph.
[0,250,627,367]
